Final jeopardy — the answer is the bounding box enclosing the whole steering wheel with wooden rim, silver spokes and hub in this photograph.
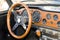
[7,2,32,39]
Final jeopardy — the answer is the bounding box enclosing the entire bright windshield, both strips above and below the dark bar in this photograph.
[11,0,60,12]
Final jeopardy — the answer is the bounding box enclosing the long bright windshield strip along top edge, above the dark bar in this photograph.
[11,0,60,4]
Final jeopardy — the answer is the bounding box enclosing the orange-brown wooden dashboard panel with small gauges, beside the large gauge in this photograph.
[31,9,60,29]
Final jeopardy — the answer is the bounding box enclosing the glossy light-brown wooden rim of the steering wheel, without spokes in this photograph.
[7,2,32,39]
